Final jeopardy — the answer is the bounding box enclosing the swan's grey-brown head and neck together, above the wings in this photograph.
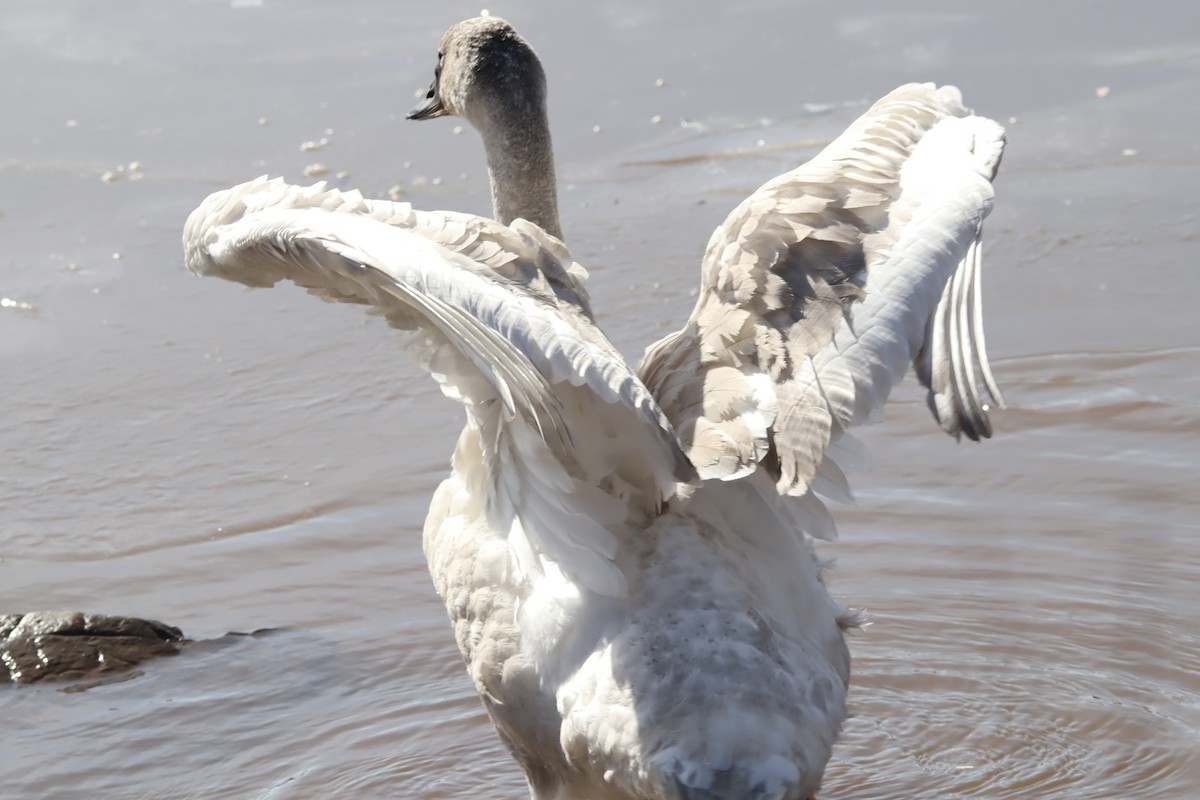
[408,17,563,239]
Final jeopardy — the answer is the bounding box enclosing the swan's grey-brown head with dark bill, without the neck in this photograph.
[408,17,546,131]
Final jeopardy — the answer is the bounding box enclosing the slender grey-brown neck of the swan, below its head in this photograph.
[481,115,563,239]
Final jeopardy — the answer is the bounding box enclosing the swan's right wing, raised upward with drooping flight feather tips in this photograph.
[638,84,1004,497]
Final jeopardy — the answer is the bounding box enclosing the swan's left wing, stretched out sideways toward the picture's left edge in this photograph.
[184,179,694,595]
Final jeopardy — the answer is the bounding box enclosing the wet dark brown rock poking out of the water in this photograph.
[0,612,186,684]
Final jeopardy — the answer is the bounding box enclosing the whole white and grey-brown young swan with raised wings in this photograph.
[184,17,1004,800]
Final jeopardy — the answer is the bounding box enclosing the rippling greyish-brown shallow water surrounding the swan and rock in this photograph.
[0,0,1200,800]
